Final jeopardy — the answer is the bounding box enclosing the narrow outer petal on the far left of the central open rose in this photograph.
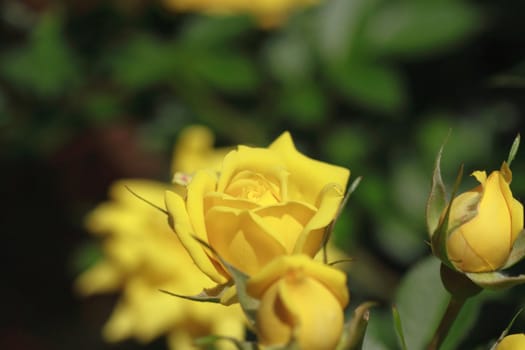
[165,191,227,284]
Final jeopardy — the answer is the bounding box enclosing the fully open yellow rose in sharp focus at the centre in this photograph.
[165,133,350,284]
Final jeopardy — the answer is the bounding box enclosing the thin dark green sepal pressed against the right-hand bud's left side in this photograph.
[430,164,466,269]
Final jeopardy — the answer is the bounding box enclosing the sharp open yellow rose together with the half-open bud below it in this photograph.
[165,133,350,350]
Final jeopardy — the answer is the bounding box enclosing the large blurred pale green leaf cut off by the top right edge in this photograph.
[364,1,480,56]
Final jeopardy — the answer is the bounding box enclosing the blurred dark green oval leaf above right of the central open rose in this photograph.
[329,62,408,113]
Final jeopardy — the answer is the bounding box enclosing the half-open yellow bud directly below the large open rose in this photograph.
[246,255,349,350]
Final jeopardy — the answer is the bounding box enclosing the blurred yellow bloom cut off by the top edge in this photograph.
[163,0,319,27]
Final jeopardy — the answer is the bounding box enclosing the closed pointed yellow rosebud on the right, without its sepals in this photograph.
[447,163,523,272]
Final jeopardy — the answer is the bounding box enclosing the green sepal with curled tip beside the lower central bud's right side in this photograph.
[336,301,377,350]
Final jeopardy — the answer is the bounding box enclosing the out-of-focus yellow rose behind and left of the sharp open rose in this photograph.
[75,180,244,350]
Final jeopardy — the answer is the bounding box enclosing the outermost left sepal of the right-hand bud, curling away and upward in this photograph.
[425,140,447,238]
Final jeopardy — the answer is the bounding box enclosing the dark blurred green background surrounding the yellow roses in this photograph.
[0,0,525,350]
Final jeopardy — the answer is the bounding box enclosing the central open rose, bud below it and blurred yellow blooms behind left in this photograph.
[76,127,350,350]
